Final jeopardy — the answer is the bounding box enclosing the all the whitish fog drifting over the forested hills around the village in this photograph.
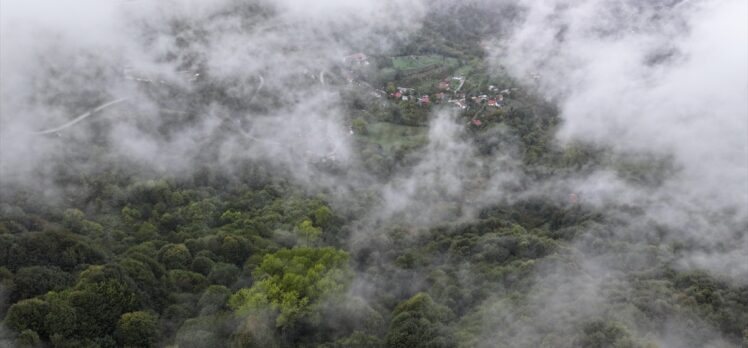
[0,0,748,347]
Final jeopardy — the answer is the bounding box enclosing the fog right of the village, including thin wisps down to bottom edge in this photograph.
[470,0,748,347]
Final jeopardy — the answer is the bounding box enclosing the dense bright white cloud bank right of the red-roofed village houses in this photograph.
[493,0,748,282]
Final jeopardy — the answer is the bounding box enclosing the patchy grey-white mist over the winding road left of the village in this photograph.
[0,0,423,189]
